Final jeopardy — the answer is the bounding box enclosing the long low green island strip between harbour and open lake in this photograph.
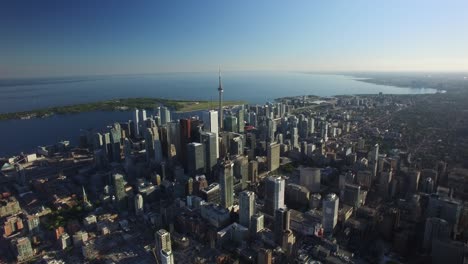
[0,98,246,121]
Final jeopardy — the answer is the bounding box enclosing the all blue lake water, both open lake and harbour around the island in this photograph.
[0,72,436,156]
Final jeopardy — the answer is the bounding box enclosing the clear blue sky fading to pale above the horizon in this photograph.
[0,0,468,78]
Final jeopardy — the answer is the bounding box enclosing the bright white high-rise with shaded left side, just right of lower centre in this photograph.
[265,176,286,215]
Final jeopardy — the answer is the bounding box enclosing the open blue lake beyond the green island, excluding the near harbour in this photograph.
[0,72,435,113]
